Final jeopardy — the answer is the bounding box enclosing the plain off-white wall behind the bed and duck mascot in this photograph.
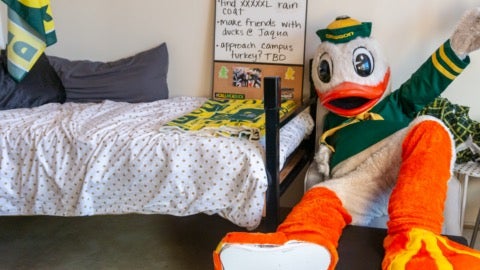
[0,0,480,120]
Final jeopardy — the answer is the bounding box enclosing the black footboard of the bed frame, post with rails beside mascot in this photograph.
[261,77,317,231]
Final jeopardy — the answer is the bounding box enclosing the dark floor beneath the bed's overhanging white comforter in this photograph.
[0,215,251,270]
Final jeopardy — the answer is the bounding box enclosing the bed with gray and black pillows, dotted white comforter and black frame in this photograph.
[0,44,316,230]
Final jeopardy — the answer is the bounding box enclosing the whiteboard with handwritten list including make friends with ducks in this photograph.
[214,0,307,65]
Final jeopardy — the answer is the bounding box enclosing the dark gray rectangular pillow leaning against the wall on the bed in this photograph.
[48,43,168,103]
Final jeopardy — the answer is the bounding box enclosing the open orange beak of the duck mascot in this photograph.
[319,69,390,117]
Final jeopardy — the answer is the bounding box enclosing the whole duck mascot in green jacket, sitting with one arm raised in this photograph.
[213,8,480,270]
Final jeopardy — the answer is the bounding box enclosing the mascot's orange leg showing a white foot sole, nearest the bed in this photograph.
[213,187,351,270]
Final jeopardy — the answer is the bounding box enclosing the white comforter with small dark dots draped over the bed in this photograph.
[0,97,314,229]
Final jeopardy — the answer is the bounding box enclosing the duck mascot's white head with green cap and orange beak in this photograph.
[312,16,390,117]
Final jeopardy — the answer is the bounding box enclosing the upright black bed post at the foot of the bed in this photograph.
[263,77,281,231]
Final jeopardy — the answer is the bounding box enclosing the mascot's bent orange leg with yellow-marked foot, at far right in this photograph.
[382,120,480,270]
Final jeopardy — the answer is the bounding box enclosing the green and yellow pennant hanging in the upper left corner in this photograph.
[2,0,57,81]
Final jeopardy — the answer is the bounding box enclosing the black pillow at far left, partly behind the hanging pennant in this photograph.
[0,50,65,110]
